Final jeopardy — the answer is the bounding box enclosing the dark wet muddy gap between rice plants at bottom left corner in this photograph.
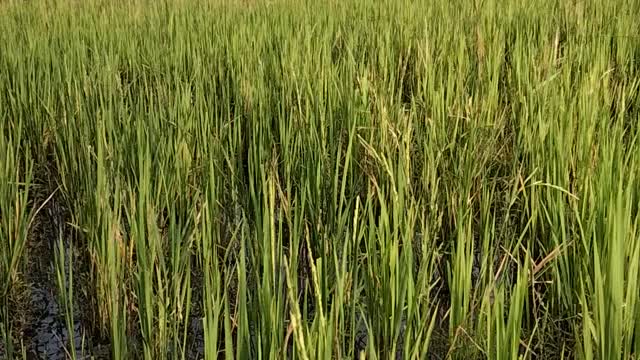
[16,193,108,360]
